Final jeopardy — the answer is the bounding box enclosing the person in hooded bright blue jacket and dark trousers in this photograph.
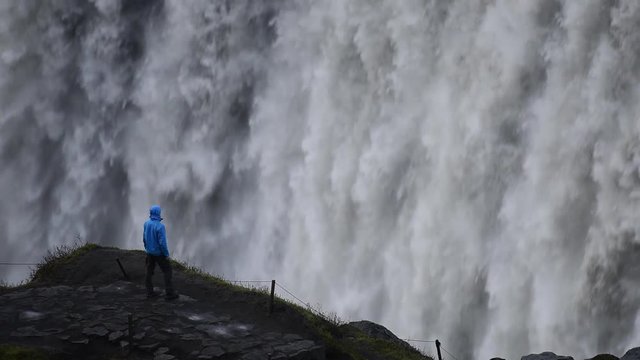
[142,205,178,300]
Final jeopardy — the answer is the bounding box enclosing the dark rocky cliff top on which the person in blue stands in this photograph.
[0,244,427,360]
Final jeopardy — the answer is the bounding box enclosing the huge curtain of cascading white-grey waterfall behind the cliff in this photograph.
[0,0,640,359]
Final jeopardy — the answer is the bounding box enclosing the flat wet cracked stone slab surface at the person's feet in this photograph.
[0,281,325,360]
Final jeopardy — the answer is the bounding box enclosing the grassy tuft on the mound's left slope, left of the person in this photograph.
[29,242,100,282]
